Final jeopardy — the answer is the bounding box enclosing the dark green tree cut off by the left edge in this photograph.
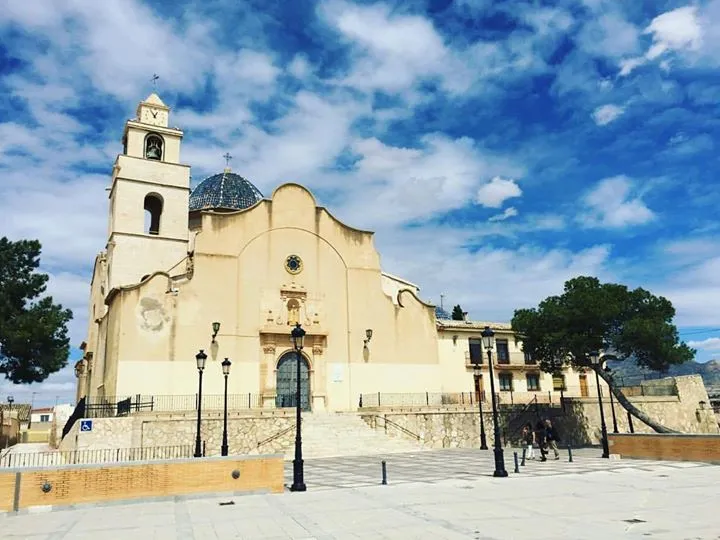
[0,237,72,384]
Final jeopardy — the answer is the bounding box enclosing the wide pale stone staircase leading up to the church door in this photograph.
[285,413,424,459]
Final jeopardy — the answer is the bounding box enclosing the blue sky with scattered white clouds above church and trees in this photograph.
[0,0,720,403]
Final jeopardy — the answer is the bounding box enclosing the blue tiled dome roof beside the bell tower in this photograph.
[190,169,263,211]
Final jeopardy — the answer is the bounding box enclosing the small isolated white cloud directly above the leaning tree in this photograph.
[578,176,655,228]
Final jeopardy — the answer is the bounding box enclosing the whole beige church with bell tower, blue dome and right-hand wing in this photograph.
[76,93,587,411]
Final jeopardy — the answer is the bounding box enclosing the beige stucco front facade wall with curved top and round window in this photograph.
[92,184,444,410]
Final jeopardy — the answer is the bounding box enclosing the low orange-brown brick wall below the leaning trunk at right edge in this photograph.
[608,433,720,463]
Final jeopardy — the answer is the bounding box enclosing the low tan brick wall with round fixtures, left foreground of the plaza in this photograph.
[0,455,284,512]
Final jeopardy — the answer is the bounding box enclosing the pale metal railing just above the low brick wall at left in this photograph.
[0,444,194,467]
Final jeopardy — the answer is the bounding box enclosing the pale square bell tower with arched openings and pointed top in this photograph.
[107,92,190,288]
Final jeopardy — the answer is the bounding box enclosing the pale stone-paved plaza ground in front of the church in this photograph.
[0,449,720,540]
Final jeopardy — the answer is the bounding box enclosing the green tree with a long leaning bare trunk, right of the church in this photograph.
[512,276,695,433]
